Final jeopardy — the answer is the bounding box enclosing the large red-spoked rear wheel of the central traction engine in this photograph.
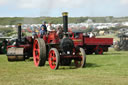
[33,39,46,66]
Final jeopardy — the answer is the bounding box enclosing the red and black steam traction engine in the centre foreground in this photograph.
[33,12,86,69]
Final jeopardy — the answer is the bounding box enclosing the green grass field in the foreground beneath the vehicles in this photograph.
[0,49,128,85]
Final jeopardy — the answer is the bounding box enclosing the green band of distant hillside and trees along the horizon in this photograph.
[0,16,128,25]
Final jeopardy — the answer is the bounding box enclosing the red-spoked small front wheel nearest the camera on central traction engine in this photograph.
[48,48,60,70]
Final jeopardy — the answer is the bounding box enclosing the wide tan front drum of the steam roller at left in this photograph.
[7,48,25,61]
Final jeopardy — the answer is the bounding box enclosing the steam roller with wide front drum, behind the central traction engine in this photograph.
[6,24,33,61]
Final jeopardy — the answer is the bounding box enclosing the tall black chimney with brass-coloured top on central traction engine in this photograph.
[62,12,68,33]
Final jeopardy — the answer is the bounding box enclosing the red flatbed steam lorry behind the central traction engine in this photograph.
[70,32,113,54]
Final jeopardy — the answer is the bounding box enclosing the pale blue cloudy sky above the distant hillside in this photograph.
[0,0,128,17]
